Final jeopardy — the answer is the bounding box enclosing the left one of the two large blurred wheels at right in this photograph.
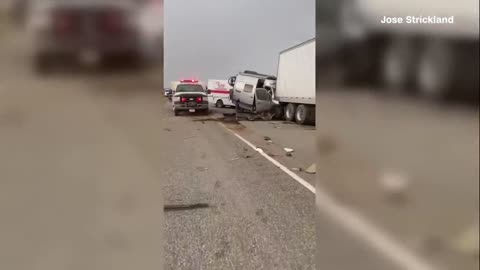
[382,37,417,93]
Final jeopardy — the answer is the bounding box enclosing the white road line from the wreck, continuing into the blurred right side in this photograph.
[219,123,438,270]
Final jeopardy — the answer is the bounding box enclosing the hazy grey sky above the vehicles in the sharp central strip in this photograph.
[164,0,315,87]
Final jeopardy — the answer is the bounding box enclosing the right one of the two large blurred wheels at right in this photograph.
[417,40,455,99]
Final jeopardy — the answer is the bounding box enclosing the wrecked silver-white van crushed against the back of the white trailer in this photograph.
[228,71,277,113]
